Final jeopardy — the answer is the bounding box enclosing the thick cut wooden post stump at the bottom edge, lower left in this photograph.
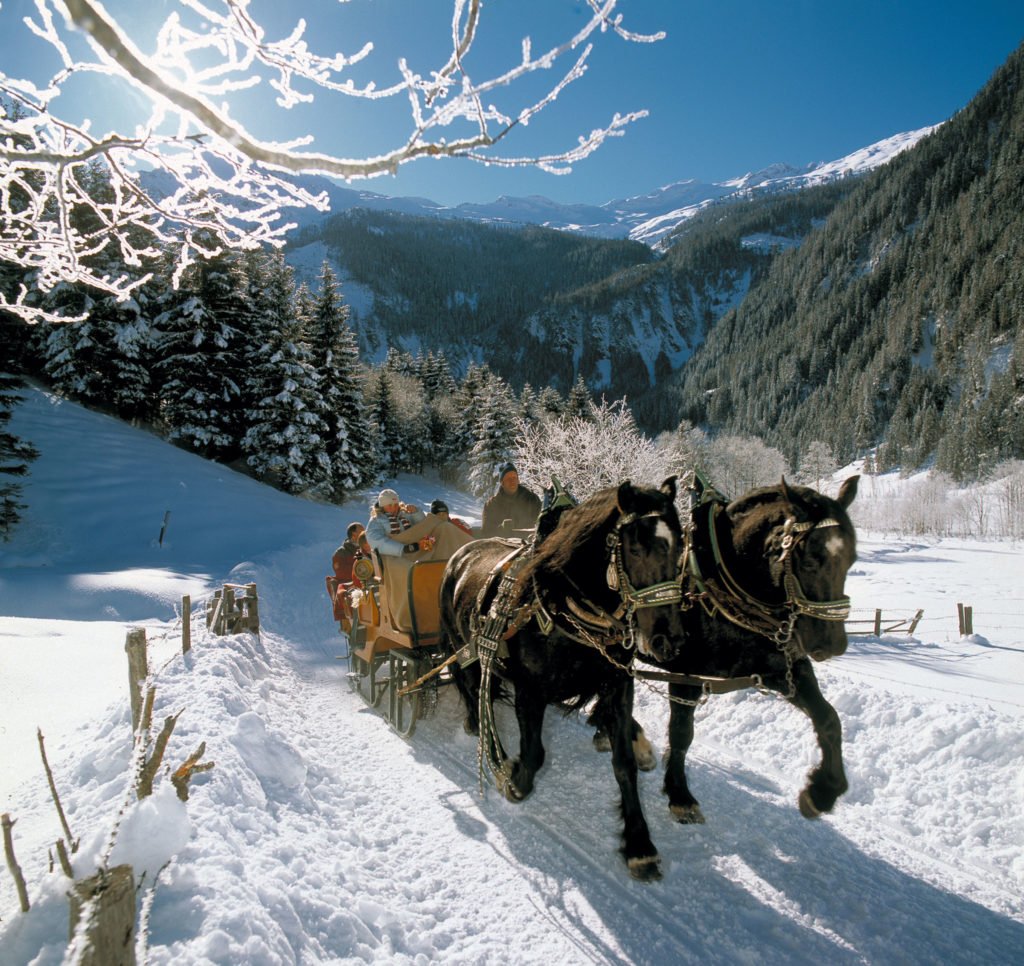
[68,866,135,966]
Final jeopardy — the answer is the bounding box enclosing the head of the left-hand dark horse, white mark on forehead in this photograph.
[608,476,683,661]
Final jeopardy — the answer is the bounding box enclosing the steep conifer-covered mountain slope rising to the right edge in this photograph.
[658,43,1024,478]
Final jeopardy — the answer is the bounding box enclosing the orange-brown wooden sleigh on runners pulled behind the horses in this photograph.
[327,555,451,738]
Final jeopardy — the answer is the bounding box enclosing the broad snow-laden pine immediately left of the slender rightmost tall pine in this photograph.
[242,254,333,493]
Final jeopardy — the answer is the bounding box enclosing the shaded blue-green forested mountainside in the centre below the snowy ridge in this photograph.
[289,179,856,399]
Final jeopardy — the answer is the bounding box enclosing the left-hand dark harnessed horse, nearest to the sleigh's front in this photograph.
[440,477,682,879]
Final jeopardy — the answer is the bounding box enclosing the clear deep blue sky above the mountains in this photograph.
[0,0,1024,204]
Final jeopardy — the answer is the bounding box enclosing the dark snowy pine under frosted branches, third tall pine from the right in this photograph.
[154,253,248,460]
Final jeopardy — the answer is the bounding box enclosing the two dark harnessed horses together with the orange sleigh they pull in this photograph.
[328,474,857,879]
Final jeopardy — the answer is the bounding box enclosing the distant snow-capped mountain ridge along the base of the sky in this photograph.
[289,126,935,246]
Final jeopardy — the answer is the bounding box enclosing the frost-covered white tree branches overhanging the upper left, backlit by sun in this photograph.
[0,0,662,321]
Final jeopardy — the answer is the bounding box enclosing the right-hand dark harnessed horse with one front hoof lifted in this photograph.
[647,476,859,823]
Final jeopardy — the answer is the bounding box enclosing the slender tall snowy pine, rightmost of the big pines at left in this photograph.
[304,261,378,500]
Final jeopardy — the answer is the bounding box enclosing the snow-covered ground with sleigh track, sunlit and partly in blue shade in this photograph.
[0,391,1024,966]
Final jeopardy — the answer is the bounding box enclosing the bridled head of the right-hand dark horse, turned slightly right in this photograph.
[728,476,860,661]
